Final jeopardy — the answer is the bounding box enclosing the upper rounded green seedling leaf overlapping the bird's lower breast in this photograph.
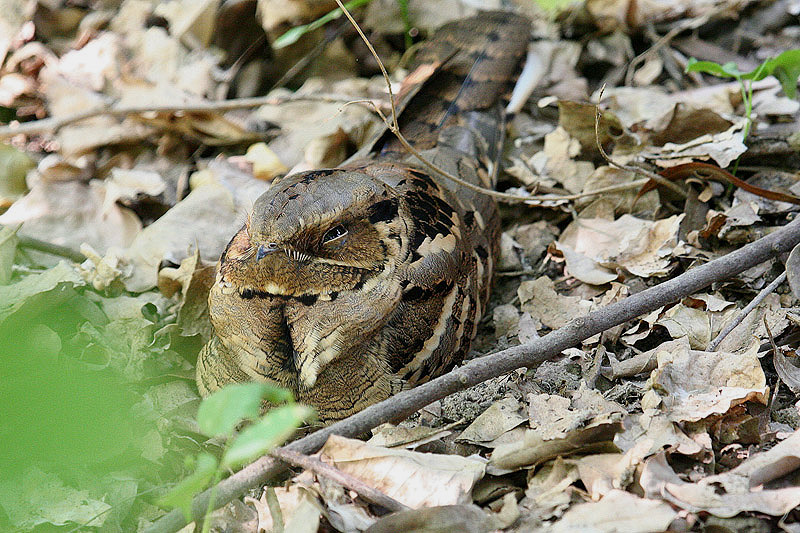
[197,383,268,436]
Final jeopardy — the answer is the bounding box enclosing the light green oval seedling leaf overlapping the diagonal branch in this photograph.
[222,404,314,468]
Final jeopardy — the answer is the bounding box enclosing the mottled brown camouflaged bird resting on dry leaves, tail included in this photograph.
[197,12,530,421]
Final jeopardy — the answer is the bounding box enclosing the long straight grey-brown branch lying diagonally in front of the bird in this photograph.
[146,210,800,533]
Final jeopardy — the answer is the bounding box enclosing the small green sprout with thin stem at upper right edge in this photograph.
[686,49,800,139]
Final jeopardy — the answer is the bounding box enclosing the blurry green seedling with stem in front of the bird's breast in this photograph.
[158,383,313,532]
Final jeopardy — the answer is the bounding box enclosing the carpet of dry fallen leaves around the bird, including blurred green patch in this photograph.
[0,0,800,531]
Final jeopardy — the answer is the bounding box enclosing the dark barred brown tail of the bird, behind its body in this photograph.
[376,11,530,179]
